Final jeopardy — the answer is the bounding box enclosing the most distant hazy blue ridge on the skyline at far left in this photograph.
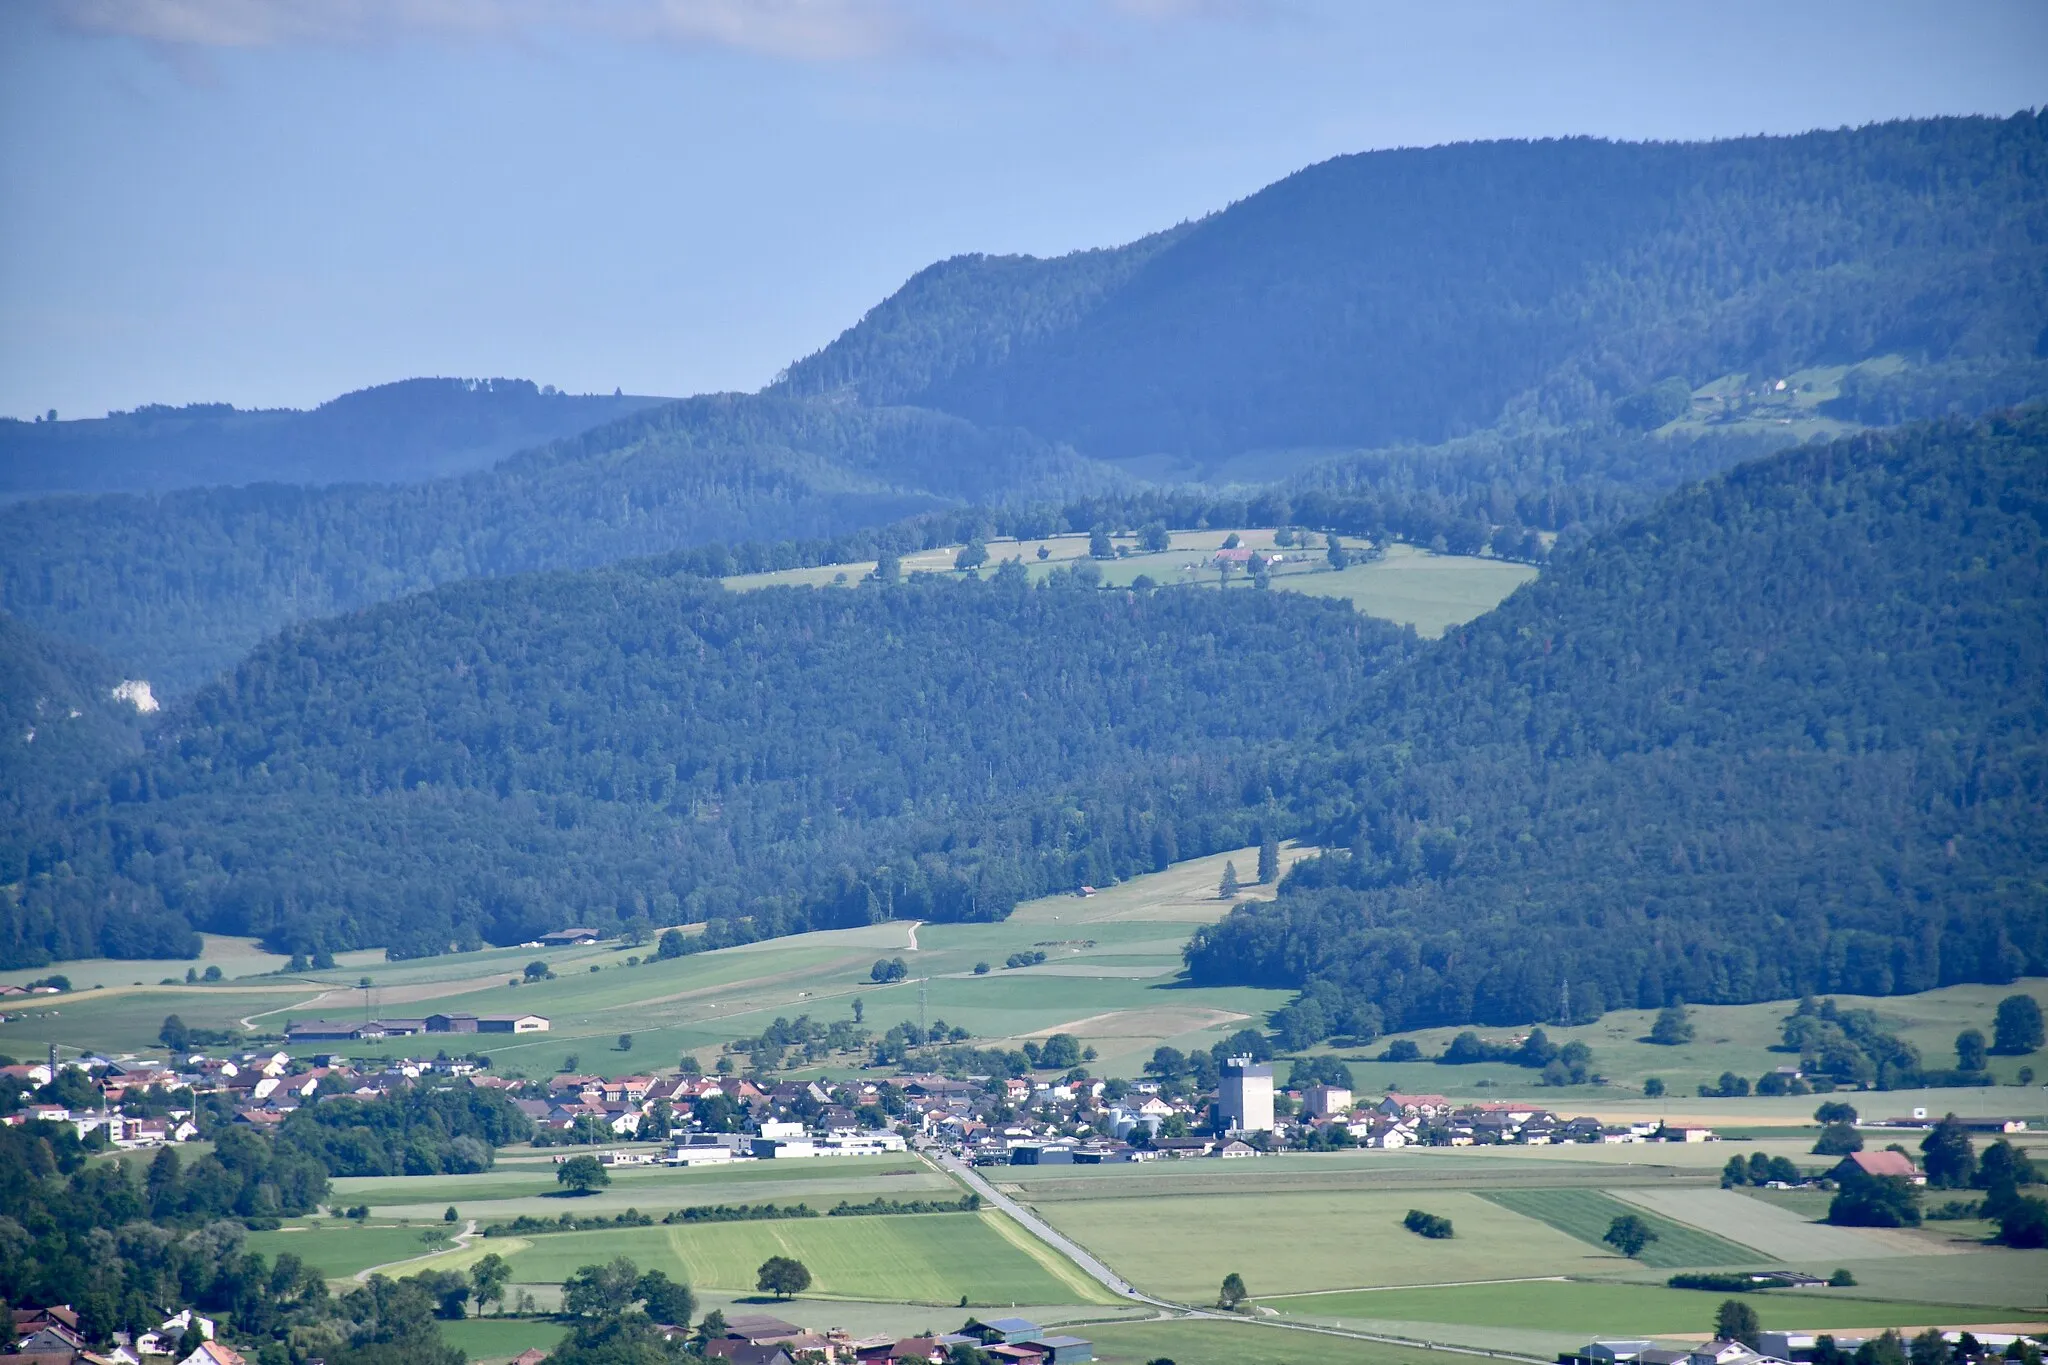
[0,379,670,497]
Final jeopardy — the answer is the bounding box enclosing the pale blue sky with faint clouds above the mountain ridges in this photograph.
[0,0,2048,417]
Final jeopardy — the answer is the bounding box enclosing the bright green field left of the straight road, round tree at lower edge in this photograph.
[487,1214,1108,1306]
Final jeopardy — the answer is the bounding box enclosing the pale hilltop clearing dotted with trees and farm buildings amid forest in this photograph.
[725,528,1536,639]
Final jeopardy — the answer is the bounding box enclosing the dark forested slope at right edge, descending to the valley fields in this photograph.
[1188,409,2048,1027]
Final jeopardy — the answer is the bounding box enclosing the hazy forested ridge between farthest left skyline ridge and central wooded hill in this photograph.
[0,395,1110,694]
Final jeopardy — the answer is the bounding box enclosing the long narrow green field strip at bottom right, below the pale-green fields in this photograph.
[1266,1279,2039,1340]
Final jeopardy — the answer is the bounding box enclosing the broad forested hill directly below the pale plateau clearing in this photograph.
[0,565,1413,964]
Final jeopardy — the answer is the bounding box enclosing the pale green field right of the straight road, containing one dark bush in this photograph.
[1036,1189,1626,1304]
